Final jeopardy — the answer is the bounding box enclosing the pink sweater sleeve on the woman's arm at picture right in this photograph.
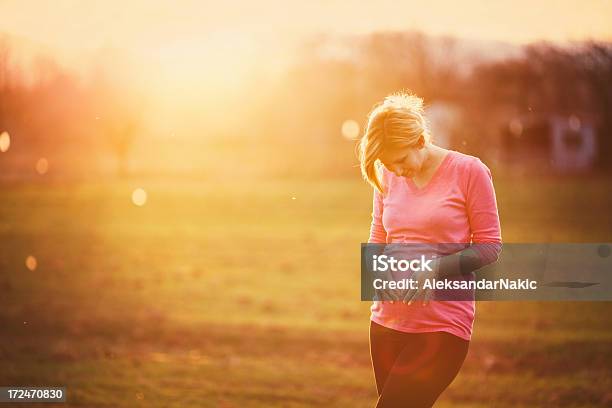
[466,159,502,266]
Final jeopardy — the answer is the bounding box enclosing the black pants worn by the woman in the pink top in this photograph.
[370,321,470,408]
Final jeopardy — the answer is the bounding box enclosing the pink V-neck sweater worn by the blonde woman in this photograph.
[368,150,501,340]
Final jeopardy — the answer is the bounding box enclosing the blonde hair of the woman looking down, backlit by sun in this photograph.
[359,92,431,194]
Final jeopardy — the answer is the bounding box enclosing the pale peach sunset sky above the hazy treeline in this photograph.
[0,0,612,49]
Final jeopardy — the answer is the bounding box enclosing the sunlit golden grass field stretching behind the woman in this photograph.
[0,179,612,407]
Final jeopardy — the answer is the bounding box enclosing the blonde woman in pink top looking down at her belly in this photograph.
[360,93,501,407]
